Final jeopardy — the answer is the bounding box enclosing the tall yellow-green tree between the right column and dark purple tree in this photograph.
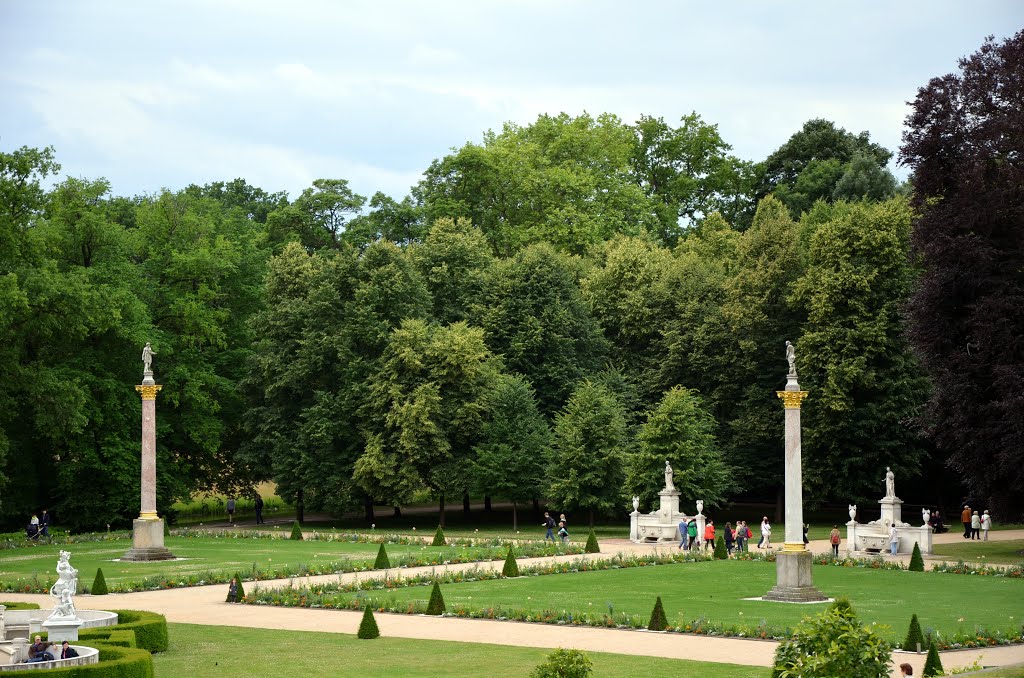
[795,199,928,501]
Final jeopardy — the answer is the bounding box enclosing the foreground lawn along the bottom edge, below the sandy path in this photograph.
[153,624,768,678]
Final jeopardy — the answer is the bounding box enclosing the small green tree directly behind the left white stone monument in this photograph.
[626,387,735,507]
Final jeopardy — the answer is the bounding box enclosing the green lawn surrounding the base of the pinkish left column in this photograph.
[0,537,520,585]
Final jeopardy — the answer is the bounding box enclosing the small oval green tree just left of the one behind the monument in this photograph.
[547,381,627,527]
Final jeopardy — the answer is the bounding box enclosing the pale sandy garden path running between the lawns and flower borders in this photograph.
[3,531,1024,676]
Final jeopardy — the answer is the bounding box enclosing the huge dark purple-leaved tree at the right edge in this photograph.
[900,32,1024,520]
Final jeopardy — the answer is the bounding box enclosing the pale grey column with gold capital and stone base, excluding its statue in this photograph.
[764,367,826,602]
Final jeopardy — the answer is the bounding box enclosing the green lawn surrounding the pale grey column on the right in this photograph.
[329,560,1024,639]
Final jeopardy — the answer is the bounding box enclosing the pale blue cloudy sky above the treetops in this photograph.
[0,0,1024,200]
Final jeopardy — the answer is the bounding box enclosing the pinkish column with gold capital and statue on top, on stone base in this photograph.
[121,342,174,560]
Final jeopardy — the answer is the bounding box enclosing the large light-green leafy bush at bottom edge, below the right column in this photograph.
[772,603,892,678]
